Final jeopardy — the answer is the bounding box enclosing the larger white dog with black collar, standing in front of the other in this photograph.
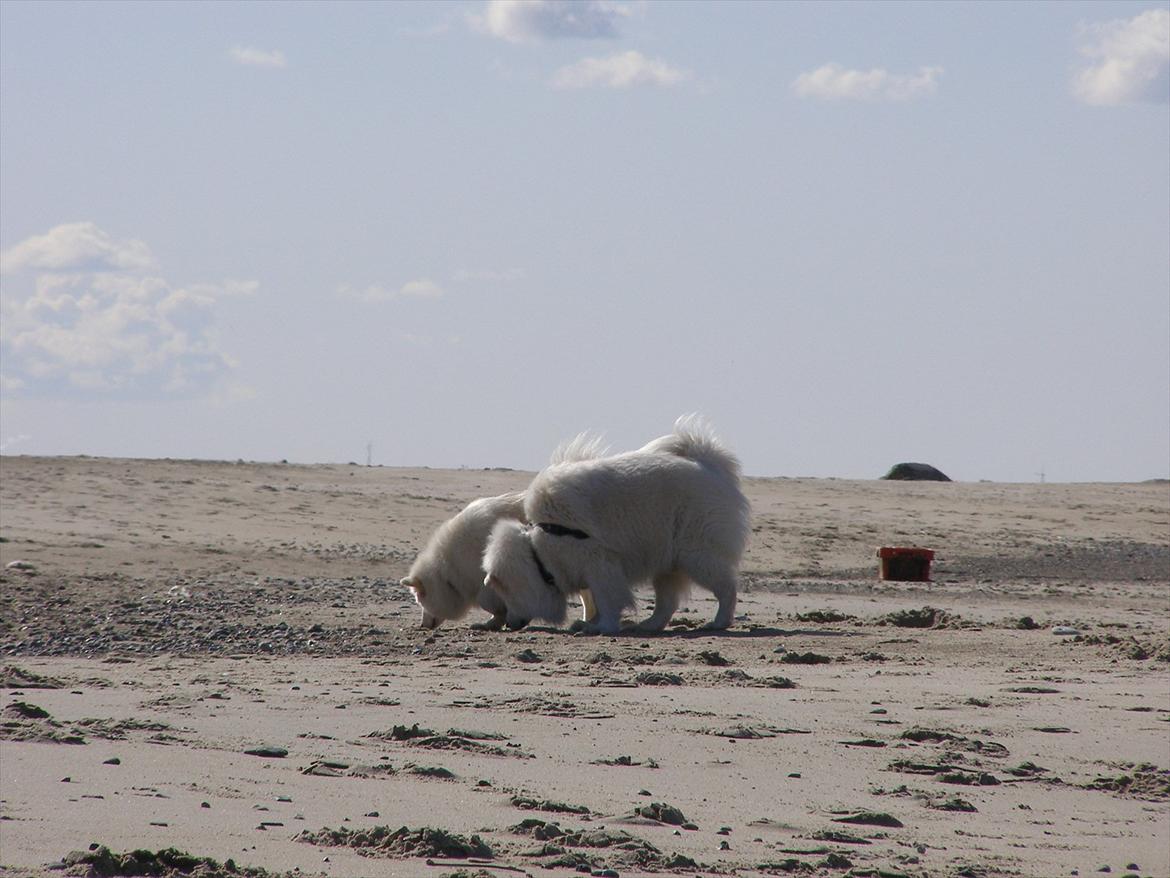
[483,416,751,635]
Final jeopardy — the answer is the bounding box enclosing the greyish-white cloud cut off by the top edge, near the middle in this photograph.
[470,0,628,42]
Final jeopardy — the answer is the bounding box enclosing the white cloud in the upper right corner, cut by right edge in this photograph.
[1073,9,1170,107]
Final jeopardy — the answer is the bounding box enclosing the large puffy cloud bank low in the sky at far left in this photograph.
[0,222,257,396]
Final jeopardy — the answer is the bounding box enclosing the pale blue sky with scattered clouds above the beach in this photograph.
[0,0,1170,482]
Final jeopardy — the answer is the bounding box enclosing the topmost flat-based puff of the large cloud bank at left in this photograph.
[0,222,154,274]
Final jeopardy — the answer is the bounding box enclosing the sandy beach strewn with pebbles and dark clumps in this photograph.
[0,457,1170,878]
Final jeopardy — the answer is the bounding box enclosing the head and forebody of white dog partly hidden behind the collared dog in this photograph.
[401,493,524,629]
